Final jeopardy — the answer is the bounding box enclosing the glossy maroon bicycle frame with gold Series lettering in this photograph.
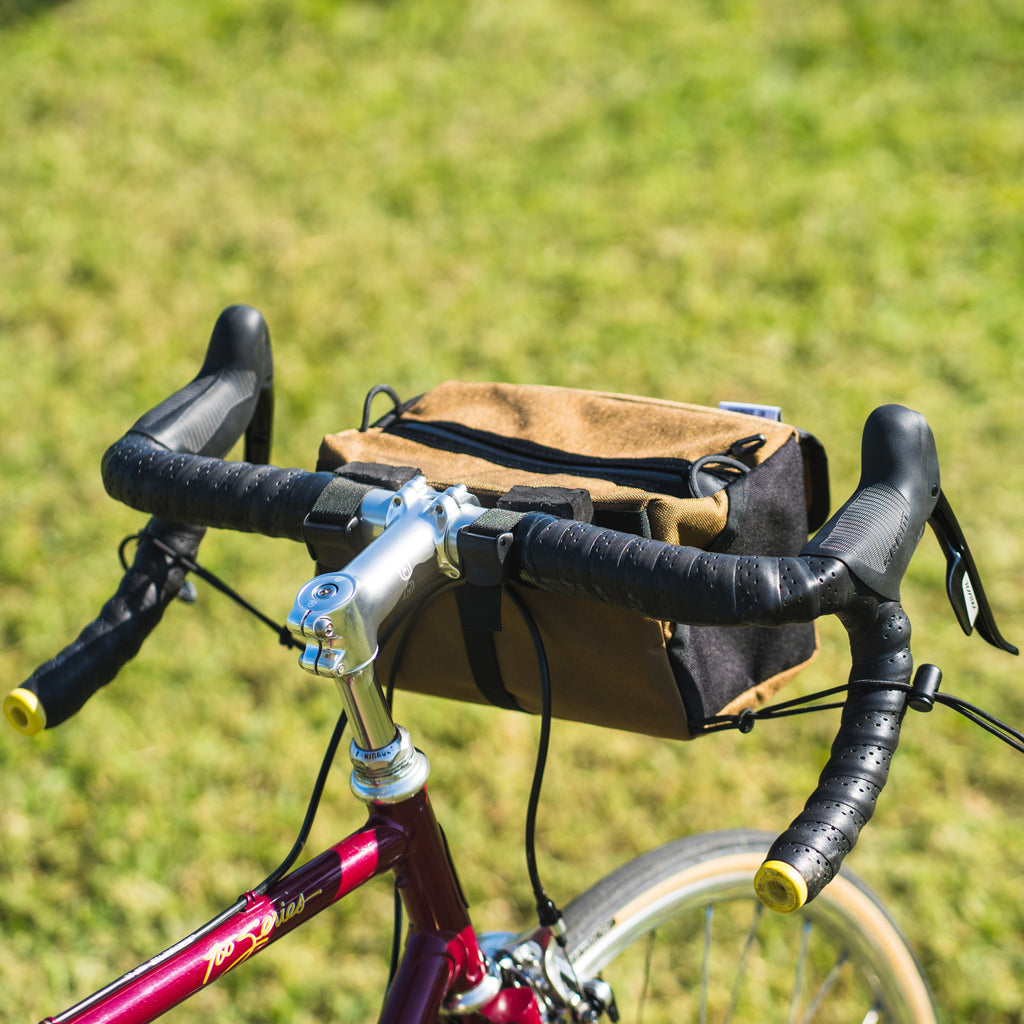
[43,790,541,1024]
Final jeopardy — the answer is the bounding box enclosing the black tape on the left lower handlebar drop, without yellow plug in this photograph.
[8,519,205,731]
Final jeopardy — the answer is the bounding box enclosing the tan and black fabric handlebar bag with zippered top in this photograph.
[316,382,828,739]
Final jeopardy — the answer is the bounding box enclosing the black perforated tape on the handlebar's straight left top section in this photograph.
[102,433,334,541]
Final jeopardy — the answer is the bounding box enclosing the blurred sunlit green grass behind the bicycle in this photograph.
[0,0,1024,1024]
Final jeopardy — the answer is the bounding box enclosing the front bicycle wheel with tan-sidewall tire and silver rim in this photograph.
[564,830,937,1024]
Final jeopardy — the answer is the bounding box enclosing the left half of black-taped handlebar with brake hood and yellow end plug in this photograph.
[4,305,323,732]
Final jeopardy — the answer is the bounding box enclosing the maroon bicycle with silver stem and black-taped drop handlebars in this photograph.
[4,307,1024,1024]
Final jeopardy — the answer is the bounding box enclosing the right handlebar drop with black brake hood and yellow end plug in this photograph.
[754,406,940,911]
